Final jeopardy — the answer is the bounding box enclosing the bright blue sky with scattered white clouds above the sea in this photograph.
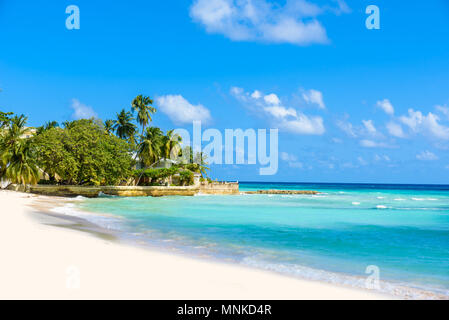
[0,0,449,183]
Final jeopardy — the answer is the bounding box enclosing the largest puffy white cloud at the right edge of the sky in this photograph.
[400,109,449,140]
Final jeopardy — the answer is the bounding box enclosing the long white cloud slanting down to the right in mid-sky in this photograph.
[231,87,326,135]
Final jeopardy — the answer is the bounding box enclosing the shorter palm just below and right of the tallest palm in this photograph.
[137,127,164,167]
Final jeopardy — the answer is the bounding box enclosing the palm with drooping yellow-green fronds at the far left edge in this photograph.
[0,115,39,185]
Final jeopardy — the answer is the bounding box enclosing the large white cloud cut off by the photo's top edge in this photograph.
[190,0,348,45]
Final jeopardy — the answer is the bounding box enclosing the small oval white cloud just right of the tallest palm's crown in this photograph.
[157,95,211,124]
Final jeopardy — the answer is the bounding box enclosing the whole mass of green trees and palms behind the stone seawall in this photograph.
[0,95,209,185]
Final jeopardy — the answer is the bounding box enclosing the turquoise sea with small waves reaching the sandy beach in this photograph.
[58,183,449,298]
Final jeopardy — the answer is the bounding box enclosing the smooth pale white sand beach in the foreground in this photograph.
[0,191,389,300]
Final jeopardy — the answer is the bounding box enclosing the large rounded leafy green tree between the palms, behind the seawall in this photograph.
[34,120,134,185]
